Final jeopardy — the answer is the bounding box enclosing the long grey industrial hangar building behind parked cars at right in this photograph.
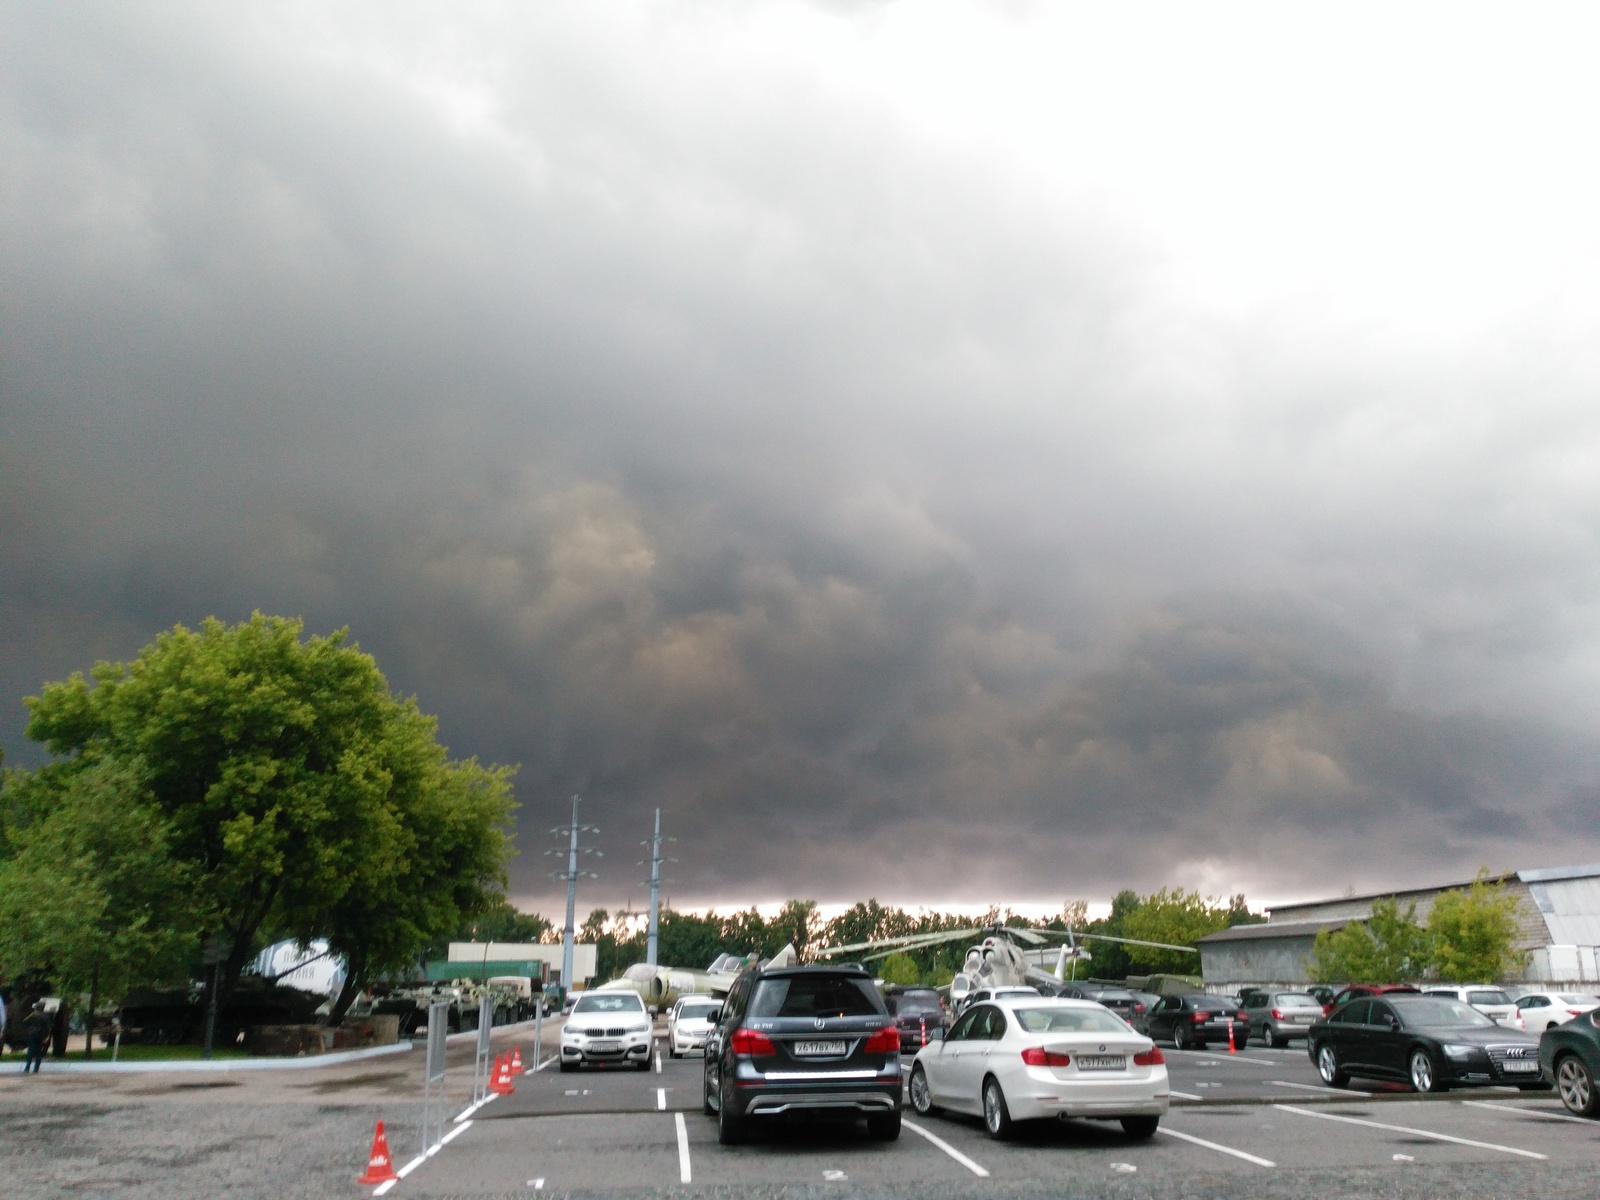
[1197,866,1600,992]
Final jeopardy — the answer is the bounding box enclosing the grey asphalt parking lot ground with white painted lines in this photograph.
[9,1026,1600,1200]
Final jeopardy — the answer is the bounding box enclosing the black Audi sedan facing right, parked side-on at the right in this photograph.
[1307,994,1549,1091]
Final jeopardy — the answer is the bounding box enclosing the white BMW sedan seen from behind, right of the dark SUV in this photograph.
[910,995,1171,1138]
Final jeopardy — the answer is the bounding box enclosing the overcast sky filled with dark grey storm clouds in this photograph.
[0,0,1600,912]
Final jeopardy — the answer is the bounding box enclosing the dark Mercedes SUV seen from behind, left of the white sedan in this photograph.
[701,963,901,1146]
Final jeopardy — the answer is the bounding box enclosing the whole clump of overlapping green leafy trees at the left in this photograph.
[0,613,515,1049]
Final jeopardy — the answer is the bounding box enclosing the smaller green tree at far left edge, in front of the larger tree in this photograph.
[0,760,203,1048]
